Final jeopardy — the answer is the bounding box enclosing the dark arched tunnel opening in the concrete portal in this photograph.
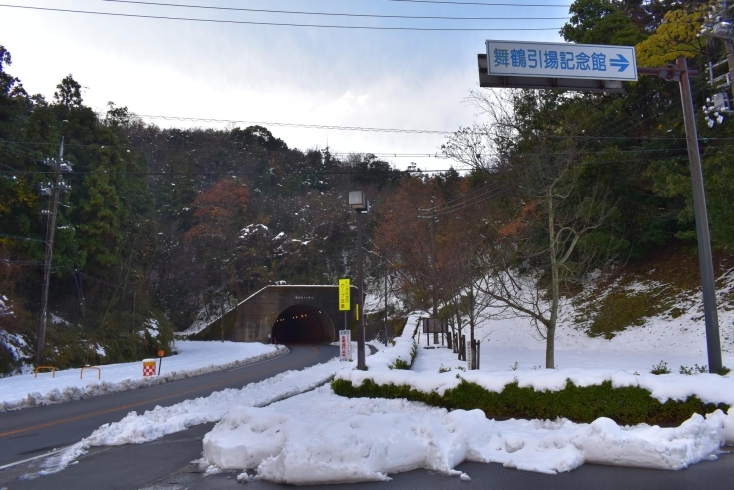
[271,305,335,344]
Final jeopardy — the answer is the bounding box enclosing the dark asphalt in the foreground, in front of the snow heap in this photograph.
[0,424,734,490]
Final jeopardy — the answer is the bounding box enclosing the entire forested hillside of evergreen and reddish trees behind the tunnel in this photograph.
[0,0,734,372]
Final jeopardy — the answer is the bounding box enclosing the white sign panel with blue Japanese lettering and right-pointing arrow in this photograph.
[487,41,637,81]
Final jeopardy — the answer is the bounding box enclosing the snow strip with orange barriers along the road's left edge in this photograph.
[0,341,287,412]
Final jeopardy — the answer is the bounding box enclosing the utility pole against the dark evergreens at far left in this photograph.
[36,136,71,366]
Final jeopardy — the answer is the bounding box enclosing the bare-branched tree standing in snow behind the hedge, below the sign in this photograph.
[444,91,618,369]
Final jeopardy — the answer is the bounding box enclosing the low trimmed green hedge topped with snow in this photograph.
[331,379,729,425]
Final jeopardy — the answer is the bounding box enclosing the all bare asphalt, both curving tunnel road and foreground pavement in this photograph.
[0,346,734,490]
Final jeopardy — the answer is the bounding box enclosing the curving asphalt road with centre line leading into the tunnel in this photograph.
[0,346,337,466]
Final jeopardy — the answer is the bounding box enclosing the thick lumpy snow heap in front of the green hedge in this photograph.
[204,386,734,485]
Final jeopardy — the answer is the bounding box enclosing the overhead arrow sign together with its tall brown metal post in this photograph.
[477,40,723,373]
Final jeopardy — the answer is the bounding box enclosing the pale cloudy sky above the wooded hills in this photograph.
[0,0,571,170]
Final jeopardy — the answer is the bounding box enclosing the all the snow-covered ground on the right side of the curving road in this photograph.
[21,286,734,484]
